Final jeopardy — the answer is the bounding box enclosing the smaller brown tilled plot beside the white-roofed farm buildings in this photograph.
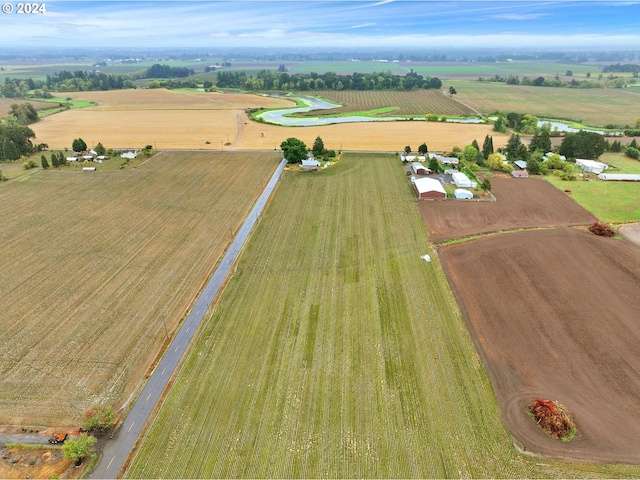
[419,178,596,242]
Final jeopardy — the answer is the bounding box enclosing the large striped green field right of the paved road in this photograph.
[127,154,640,478]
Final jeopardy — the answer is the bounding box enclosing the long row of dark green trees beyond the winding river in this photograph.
[216,70,442,91]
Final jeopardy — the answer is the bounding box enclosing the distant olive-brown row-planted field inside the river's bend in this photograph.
[302,90,475,118]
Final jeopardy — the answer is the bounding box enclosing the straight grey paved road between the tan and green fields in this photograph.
[91,160,287,478]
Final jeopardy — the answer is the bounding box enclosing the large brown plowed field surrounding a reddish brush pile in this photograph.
[439,228,640,464]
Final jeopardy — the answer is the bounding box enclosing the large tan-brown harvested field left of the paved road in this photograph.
[0,152,279,426]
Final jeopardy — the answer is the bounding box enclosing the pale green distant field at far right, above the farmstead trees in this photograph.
[445,80,640,127]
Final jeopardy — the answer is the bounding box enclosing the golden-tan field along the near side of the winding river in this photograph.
[32,89,508,151]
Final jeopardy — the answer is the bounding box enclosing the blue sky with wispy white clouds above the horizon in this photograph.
[0,0,640,50]
